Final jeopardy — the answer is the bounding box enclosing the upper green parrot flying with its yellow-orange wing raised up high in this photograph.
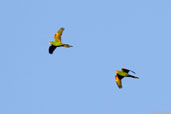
[49,27,72,54]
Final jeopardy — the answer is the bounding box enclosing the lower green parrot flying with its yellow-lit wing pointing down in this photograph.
[115,68,139,88]
